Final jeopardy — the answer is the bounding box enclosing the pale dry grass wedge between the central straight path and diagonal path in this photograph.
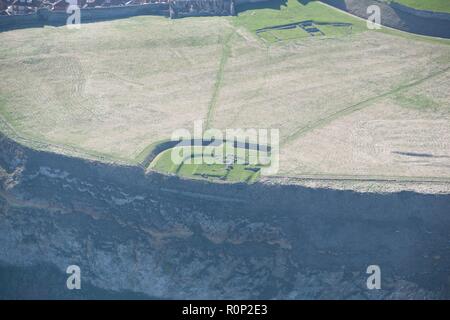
[213,32,450,144]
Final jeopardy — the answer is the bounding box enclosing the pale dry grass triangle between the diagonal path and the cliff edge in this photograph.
[280,91,450,180]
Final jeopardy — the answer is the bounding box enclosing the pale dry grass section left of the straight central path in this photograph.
[0,18,230,159]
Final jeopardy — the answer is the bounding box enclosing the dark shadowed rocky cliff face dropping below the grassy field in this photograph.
[0,133,450,299]
